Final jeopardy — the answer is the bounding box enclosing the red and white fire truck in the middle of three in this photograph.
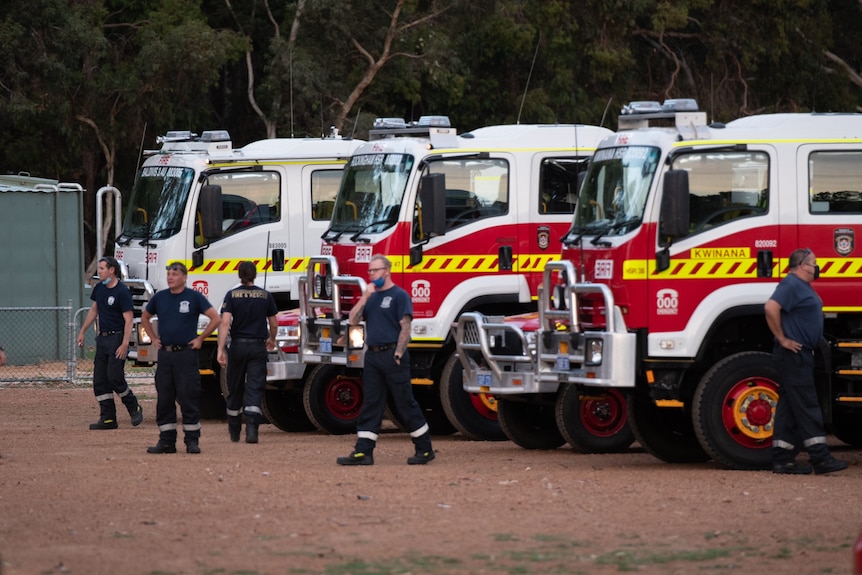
[292,116,611,439]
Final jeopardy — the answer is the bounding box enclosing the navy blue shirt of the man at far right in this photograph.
[769,274,823,349]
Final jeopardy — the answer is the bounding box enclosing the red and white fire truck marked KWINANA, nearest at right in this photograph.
[457,100,862,469]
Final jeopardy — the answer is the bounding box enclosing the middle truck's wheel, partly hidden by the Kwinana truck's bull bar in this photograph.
[440,354,506,441]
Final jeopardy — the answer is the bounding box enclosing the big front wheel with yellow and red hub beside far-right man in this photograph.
[692,351,778,469]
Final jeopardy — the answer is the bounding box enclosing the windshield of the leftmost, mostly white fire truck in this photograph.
[123,166,194,240]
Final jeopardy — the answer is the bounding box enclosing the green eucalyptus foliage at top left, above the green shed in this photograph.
[0,0,243,266]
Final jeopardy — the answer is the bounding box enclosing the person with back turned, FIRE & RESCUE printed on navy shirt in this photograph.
[218,262,278,443]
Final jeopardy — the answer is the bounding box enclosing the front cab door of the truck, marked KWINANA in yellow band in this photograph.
[647,147,780,340]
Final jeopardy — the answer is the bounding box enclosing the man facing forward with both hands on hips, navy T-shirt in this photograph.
[141,262,219,453]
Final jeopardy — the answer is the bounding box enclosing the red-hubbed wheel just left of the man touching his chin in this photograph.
[302,364,362,435]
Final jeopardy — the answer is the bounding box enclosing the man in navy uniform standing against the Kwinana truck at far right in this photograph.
[765,248,847,475]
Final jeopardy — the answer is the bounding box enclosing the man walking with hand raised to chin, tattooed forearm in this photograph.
[336,255,434,465]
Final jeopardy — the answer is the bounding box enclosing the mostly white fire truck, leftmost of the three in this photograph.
[97,130,361,418]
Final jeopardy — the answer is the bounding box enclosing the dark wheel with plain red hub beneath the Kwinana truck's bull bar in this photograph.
[555,383,635,453]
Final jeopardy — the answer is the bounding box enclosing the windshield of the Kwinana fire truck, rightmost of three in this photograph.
[572,146,659,236]
